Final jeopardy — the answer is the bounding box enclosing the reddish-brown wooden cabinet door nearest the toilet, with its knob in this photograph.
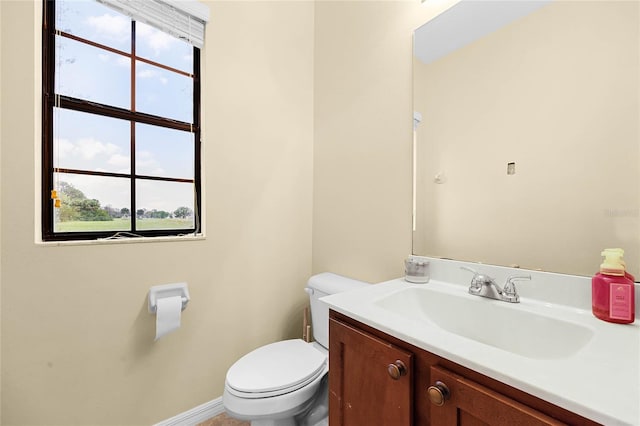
[329,319,413,426]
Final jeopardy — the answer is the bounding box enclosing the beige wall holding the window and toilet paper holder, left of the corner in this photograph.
[0,0,313,425]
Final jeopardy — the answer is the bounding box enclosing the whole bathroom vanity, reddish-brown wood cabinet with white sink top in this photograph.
[323,260,640,426]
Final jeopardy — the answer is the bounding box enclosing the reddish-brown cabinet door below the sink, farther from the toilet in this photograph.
[426,366,565,426]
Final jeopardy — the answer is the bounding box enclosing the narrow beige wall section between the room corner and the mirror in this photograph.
[313,1,454,282]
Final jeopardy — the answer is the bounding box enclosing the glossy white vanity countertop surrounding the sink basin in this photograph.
[322,263,640,426]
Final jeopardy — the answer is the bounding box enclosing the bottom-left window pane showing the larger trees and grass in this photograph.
[53,173,131,232]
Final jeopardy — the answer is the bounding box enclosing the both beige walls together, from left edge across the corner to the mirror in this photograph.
[0,0,460,425]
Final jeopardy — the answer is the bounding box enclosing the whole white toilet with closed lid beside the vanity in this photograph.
[222,272,368,426]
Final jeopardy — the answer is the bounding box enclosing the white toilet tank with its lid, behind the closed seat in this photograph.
[305,272,369,348]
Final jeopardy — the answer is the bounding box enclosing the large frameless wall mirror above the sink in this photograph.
[413,0,640,278]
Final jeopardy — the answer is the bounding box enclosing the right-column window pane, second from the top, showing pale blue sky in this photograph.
[136,61,193,123]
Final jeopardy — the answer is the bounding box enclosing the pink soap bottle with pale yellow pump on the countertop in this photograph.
[591,249,636,324]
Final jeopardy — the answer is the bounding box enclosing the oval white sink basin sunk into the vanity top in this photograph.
[374,285,593,359]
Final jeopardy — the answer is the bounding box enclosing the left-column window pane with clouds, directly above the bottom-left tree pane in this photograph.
[53,108,131,173]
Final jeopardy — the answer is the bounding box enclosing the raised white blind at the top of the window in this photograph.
[97,0,209,48]
